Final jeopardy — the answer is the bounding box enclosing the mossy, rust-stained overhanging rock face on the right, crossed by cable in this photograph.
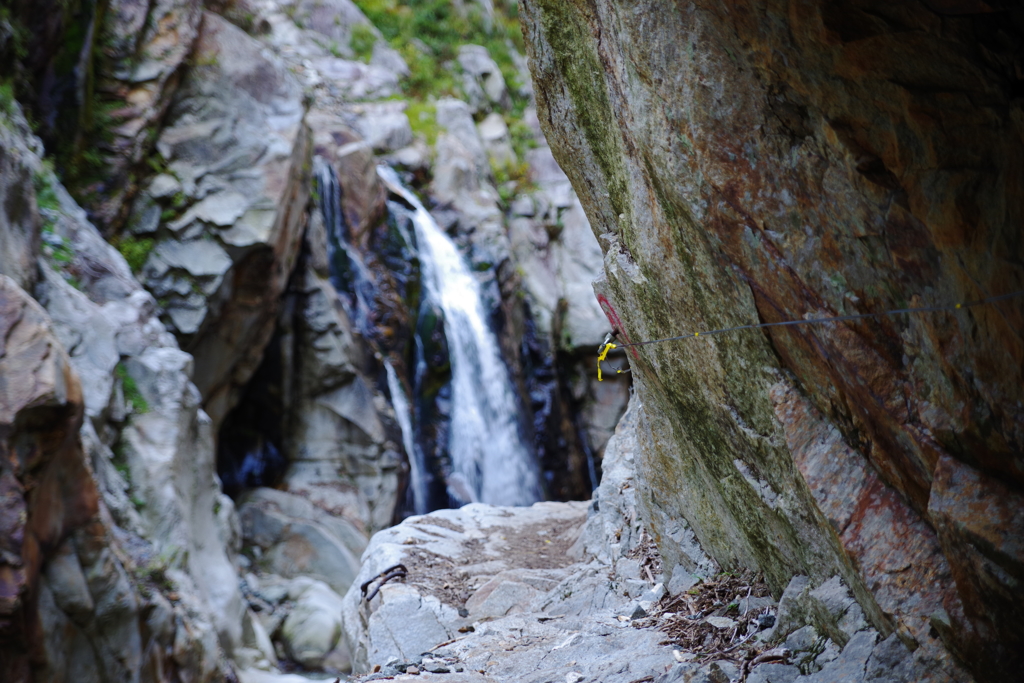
[521,0,1024,680]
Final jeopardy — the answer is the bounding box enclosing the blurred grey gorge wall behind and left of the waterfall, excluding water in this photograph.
[0,0,629,681]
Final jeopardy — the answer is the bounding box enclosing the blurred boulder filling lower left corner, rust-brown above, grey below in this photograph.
[0,275,224,682]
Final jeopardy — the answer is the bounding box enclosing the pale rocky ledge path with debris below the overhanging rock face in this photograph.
[327,397,950,683]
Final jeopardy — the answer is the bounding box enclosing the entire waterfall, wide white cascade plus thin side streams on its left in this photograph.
[313,157,541,514]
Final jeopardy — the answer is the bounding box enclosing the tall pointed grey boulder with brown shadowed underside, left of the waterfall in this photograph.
[130,13,310,425]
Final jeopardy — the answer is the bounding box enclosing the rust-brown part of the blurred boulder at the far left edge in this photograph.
[0,275,90,681]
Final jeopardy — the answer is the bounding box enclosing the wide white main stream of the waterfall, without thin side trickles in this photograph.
[378,166,541,505]
